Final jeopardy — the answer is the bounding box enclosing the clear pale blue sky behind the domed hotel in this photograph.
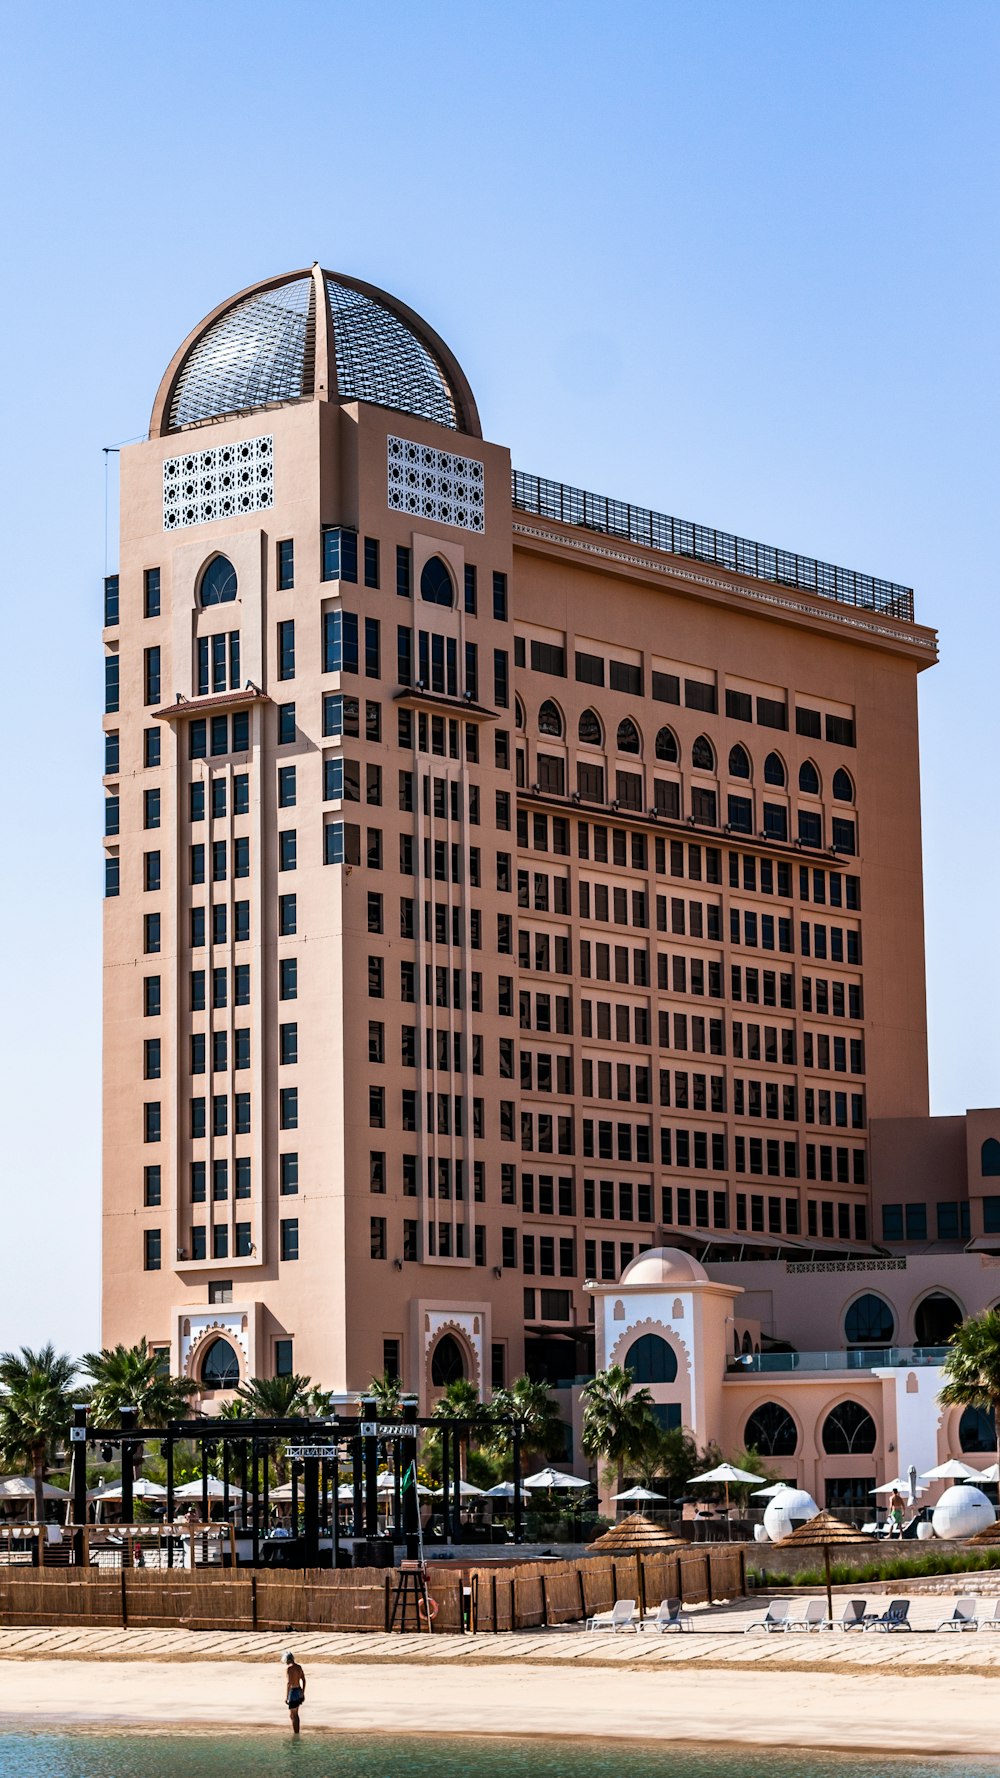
[0,0,1000,1350]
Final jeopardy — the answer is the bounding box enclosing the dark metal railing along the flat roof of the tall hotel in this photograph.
[511,469,913,624]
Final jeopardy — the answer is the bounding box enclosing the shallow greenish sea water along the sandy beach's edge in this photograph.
[0,1732,998,1778]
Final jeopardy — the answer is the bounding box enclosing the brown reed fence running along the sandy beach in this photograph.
[0,1545,746,1634]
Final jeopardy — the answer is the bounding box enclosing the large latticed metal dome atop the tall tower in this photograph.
[149,265,482,437]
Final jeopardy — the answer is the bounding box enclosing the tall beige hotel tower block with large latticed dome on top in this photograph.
[103,267,936,1408]
